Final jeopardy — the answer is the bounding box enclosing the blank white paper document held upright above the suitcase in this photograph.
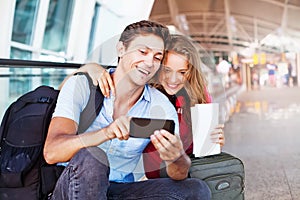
[191,103,221,157]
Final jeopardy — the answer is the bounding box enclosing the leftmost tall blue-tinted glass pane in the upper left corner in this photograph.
[12,0,39,45]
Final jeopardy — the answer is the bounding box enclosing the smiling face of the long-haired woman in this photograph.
[159,52,188,95]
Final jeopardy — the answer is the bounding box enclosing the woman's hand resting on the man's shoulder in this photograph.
[76,63,115,97]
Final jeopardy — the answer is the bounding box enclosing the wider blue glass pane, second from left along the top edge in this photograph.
[43,0,73,52]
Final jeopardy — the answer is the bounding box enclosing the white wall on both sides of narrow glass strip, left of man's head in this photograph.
[67,0,154,64]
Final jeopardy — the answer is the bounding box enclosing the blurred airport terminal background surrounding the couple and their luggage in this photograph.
[0,0,300,200]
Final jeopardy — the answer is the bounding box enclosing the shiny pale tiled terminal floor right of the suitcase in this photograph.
[223,87,300,200]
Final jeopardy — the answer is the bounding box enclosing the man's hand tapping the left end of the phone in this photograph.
[104,116,131,140]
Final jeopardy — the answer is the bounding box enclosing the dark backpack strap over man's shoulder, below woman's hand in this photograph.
[75,72,104,134]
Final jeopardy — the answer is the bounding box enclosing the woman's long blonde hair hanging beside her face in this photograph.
[154,34,207,106]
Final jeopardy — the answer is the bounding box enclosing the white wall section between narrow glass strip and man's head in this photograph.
[87,0,154,65]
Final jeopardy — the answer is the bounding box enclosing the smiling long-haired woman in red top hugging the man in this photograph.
[75,35,225,178]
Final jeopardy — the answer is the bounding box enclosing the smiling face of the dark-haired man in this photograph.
[118,34,164,86]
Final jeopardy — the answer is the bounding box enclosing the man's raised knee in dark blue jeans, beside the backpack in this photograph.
[53,147,109,199]
